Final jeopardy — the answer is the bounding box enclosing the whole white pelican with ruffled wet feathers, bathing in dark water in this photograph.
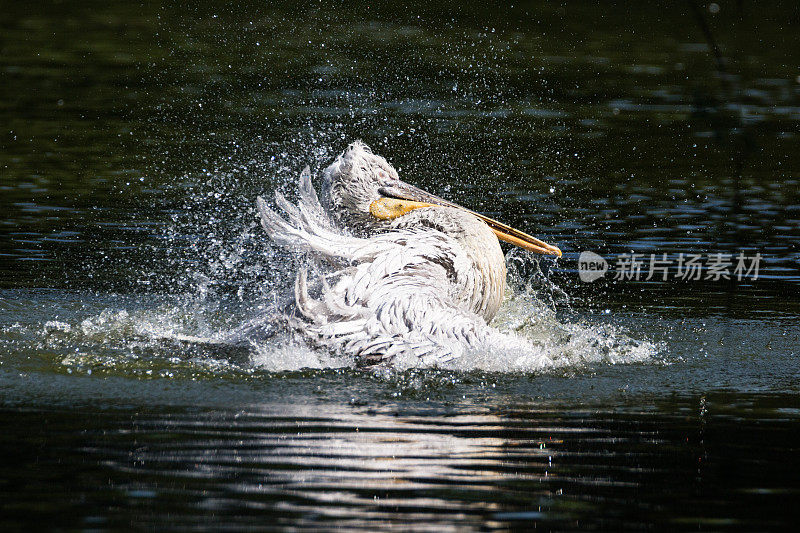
[256,141,561,366]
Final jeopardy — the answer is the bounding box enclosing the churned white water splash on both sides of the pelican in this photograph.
[21,243,664,379]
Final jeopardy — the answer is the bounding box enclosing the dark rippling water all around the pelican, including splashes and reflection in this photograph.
[0,1,800,531]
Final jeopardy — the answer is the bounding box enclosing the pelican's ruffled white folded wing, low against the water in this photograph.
[295,260,482,365]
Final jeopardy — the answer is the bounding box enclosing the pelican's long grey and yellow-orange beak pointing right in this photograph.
[369,181,561,257]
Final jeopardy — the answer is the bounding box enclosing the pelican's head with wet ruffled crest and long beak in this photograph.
[322,141,561,257]
